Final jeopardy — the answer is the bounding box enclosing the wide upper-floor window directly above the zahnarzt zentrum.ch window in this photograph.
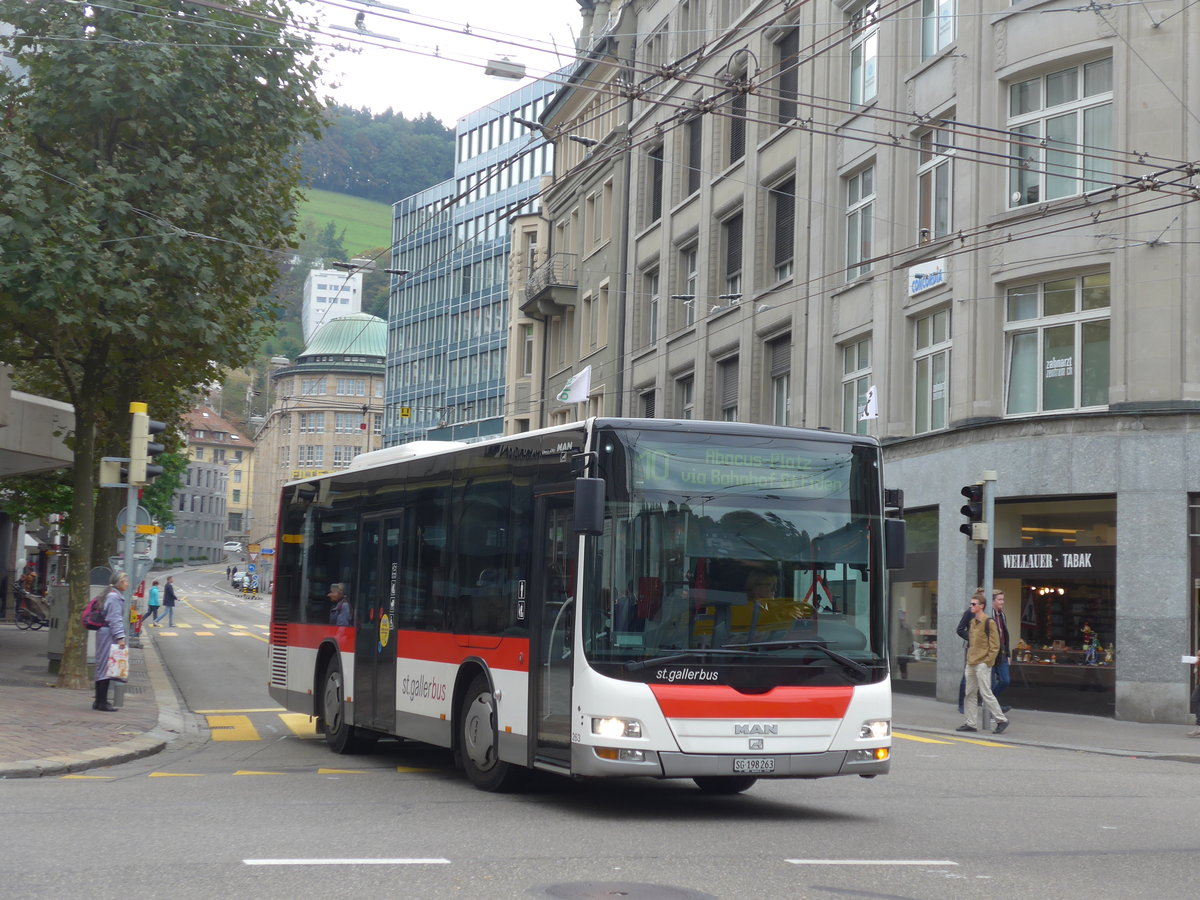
[1008,59,1112,206]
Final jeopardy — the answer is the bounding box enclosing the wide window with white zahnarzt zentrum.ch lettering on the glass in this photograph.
[1004,272,1110,415]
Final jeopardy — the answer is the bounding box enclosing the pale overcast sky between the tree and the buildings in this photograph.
[319,0,581,128]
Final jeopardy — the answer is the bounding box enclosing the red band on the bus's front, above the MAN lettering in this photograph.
[650,684,854,719]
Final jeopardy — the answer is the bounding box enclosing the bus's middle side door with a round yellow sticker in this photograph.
[350,515,401,734]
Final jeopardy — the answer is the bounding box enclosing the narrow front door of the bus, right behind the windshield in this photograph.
[530,491,578,766]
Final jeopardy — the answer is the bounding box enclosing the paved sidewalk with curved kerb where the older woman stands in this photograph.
[0,622,182,779]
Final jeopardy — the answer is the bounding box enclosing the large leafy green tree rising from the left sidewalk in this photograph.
[0,0,320,688]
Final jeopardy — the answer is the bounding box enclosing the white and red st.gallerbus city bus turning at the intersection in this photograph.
[269,419,904,792]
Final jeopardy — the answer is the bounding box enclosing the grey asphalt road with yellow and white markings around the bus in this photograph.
[0,568,1200,900]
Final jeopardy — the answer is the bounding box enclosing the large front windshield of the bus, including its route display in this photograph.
[581,428,887,690]
